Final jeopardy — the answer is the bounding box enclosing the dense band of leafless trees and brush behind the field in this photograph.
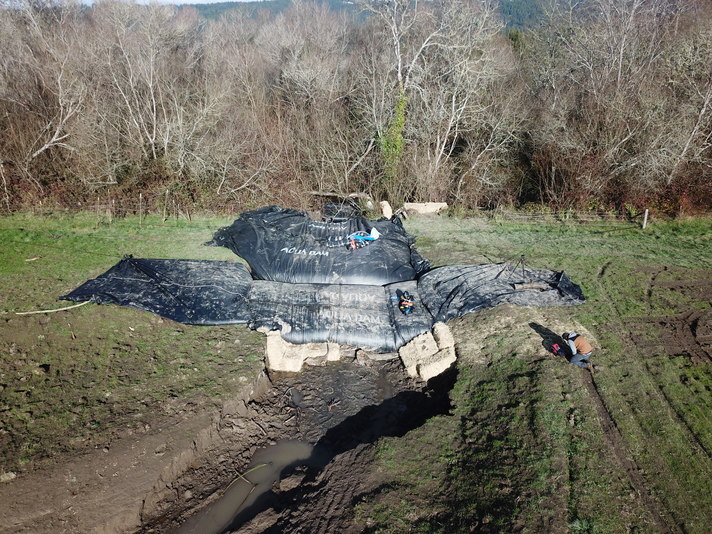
[0,0,712,213]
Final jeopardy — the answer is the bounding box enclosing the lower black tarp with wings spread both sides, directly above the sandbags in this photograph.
[62,264,584,352]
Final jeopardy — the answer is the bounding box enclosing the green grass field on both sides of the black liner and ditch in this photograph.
[0,211,712,533]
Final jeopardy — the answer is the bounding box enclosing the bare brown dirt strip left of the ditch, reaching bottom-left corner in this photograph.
[0,374,269,534]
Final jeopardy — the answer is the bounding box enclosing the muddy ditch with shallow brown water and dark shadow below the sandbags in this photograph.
[159,361,454,534]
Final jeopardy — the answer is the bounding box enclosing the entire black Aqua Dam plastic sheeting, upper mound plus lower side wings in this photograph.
[61,207,585,352]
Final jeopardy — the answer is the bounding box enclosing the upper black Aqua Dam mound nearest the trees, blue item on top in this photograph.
[207,206,429,286]
